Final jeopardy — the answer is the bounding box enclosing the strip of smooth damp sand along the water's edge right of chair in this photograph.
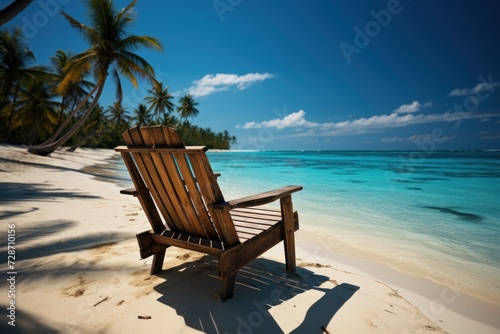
[292,227,500,333]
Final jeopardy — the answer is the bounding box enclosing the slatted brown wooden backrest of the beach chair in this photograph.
[122,126,239,245]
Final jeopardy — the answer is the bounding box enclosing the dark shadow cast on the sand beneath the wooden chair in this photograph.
[154,255,359,333]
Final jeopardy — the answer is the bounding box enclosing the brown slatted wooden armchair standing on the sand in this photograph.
[115,126,302,300]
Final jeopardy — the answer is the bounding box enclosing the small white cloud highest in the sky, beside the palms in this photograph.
[188,73,273,97]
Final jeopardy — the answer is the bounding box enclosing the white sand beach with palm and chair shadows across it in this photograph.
[0,146,500,333]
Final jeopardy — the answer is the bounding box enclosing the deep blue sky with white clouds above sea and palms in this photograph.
[9,0,500,151]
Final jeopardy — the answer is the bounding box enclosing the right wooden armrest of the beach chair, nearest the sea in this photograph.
[211,186,303,211]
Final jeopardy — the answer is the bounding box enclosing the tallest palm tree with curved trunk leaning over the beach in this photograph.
[28,0,162,155]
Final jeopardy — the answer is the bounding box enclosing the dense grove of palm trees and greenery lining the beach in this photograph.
[0,0,236,155]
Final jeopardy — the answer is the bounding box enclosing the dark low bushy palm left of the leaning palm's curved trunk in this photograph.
[10,80,61,145]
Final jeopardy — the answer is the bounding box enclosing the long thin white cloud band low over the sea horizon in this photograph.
[237,110,498,136]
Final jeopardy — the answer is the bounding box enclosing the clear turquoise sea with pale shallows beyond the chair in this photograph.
[115,151,500,301]
